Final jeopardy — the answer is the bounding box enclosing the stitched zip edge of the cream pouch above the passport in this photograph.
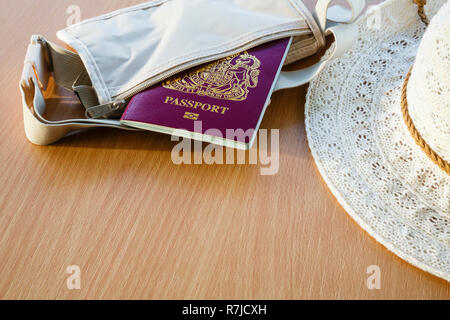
[108,20,310,96]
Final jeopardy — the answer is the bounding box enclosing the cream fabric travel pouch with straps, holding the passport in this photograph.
[21,0,364,145]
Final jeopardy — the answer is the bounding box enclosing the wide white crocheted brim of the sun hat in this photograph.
[305,0,450,281]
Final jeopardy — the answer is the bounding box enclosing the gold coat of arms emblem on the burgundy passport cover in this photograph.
[163,51,261,101]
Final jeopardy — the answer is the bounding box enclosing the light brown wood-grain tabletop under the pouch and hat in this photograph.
[0,0,450,299]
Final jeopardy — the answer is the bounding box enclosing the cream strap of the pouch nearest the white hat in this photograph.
[274,0,365,91]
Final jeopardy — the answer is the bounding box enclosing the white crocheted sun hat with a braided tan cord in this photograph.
[305,0,450,281]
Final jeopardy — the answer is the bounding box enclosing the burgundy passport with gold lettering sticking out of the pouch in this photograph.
[120,38,291,149]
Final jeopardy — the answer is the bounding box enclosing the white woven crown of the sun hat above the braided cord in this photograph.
[407,2,450,162]
